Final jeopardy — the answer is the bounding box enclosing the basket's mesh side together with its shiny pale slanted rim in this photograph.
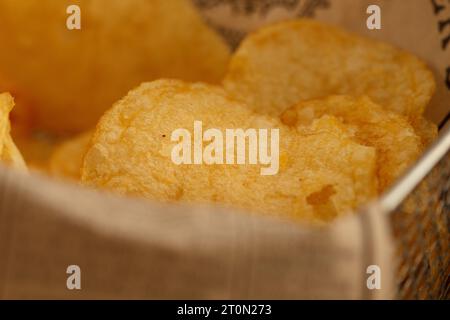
[381,123,450,299]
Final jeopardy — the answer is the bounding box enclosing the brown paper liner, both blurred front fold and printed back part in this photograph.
[0,0,450,299]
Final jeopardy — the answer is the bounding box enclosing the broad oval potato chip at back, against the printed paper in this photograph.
[224,19,435,118]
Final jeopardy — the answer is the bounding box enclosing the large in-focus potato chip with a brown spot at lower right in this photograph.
[81,80,377,221]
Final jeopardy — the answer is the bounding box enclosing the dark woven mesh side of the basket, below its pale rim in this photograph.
[390,152,450,299]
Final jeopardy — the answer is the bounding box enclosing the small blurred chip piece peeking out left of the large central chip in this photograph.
[49,131,93,181]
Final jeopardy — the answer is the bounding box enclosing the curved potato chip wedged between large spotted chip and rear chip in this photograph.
[281,96,423,191]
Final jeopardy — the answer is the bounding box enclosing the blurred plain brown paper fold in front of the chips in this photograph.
[0,170,392,299]
